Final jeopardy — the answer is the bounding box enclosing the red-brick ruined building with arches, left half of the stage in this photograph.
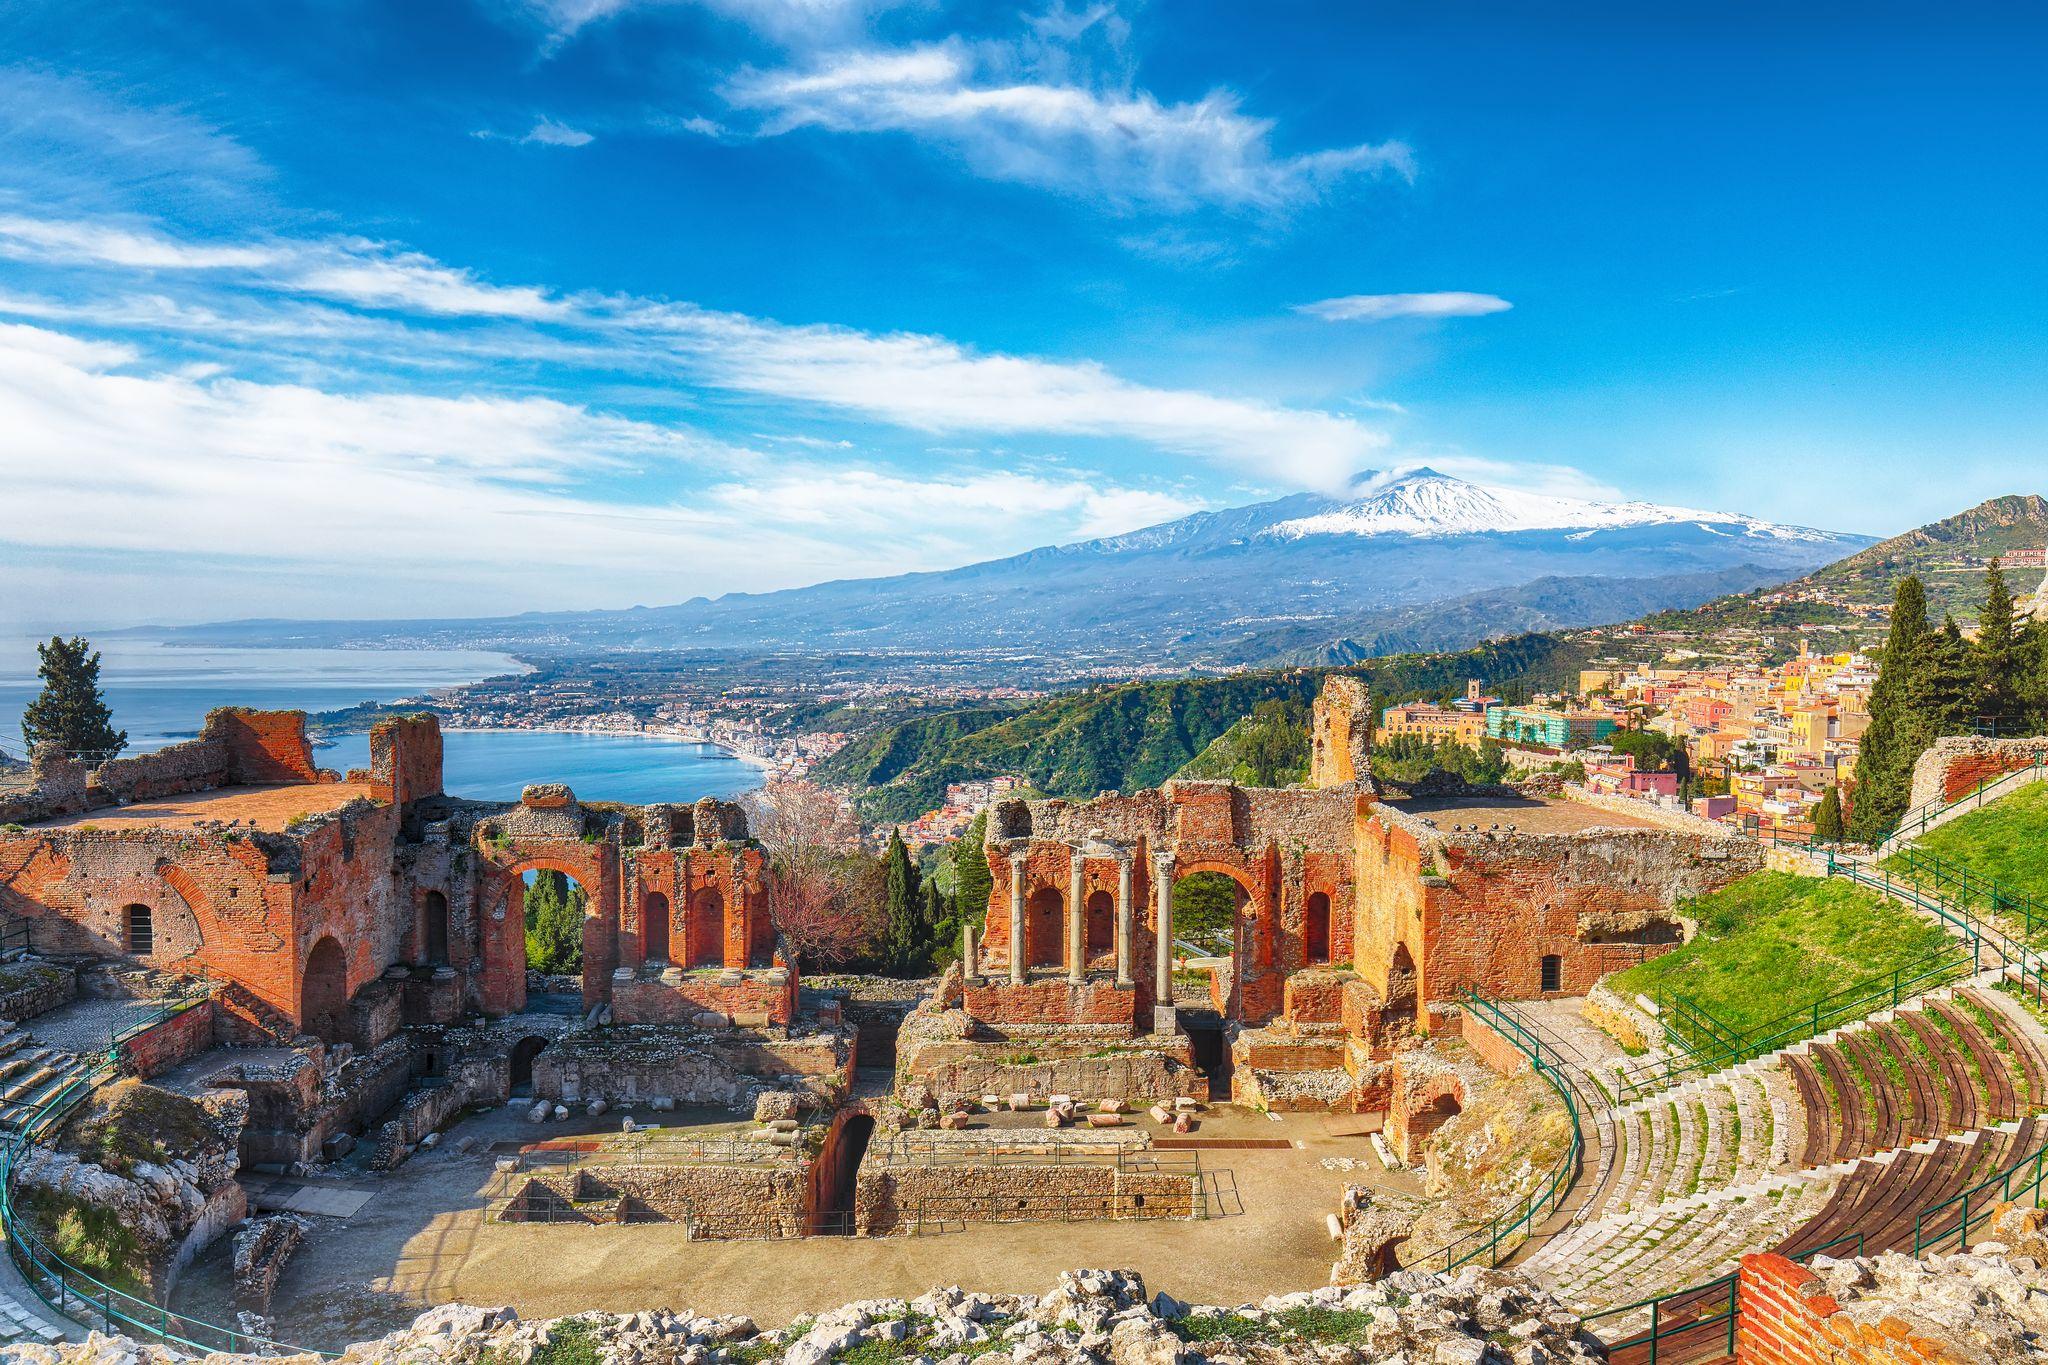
[0,710,797,1046]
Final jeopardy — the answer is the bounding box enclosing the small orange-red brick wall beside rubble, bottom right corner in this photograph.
[1735,1252,1982,1365]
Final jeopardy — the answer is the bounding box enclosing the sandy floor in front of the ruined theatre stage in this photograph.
[176,1107,1419,1347]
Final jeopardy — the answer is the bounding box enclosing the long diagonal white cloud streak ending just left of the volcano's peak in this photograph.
[0,210,1386,489]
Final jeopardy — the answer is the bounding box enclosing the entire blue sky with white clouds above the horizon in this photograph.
[0,0,2048,626]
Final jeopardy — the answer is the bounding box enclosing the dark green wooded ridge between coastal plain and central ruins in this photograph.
[817,634,1585,821]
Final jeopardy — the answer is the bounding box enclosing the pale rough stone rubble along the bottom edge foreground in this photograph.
[10,1267,1606,1365]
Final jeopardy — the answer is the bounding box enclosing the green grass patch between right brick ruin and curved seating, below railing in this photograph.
[1608,872,1950,1031]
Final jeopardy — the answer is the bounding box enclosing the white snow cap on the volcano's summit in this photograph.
[1262,469,1835,542]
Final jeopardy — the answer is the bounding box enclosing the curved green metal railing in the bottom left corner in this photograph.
[0,1033,338,1359]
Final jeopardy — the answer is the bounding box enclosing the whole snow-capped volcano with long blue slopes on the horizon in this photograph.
[144,469,1870,669]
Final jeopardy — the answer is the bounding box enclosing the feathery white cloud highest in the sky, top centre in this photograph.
[725,39,1413,211]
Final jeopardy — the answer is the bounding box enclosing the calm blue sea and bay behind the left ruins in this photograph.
[0,636,762,804]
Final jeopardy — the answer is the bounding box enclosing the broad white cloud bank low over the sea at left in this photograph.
[0,323,1212,618]
